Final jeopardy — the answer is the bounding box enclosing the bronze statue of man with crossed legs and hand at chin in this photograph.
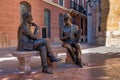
[17,12,60,74]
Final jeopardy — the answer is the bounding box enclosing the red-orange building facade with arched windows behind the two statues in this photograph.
[0,0,87,47]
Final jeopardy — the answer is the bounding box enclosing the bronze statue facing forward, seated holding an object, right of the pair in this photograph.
[60,14,82,67]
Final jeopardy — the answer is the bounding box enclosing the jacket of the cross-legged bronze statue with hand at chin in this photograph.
[17,24,37,51]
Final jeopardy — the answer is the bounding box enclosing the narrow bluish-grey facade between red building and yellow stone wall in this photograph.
[87,0,101,44]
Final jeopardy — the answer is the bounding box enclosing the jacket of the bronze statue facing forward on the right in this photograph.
[60,24,81,44]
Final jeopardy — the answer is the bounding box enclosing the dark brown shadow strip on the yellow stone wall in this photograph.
[98,0,110,45]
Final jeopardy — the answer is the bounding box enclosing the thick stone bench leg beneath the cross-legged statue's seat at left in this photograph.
[17,57,31,73]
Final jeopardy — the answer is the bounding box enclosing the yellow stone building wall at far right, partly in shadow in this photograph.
[101,0,120,46]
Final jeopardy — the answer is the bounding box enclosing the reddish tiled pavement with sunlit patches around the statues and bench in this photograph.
[0,44,120,80]
